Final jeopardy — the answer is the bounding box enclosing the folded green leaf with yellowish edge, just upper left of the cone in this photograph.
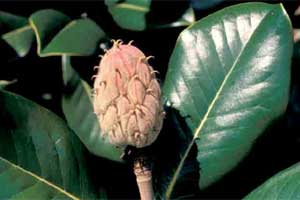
[29,9,105,57]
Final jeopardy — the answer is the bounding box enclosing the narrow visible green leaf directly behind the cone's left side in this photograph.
[62,56,122,162]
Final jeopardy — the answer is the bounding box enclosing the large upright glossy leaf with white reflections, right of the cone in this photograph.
[163,3,293,198]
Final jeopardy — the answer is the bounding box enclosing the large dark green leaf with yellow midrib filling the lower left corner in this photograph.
[0,90,95,199]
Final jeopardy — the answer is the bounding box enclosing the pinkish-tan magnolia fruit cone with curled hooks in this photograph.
[94,40,164,148]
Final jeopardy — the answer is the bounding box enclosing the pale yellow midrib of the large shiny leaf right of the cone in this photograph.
[166,6,273,199]
